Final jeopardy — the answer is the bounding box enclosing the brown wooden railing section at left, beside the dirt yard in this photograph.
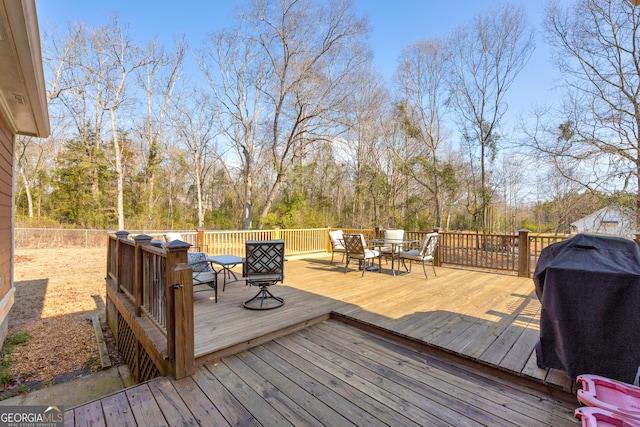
[106,231,195,381]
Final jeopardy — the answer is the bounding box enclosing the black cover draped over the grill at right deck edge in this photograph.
[533,234,640,383]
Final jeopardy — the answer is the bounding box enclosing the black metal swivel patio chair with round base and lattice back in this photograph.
[242,240,284,310]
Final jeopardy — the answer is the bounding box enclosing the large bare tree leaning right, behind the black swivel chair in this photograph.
[235,0,368,228]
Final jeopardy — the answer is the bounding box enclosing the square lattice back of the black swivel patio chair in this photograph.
[242,240,284,281]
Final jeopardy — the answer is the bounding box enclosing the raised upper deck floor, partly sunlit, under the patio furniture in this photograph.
[189,257,573,391]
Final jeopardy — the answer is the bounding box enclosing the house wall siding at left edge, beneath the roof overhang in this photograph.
[0,116,15,346]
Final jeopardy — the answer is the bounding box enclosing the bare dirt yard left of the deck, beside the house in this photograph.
[9,248,123,392]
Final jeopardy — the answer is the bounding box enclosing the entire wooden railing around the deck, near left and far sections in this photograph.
[101,228,596,381]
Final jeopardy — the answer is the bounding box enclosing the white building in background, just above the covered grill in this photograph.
[571,205,636,237]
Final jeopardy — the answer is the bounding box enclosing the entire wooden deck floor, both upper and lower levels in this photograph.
[65,256,578,426]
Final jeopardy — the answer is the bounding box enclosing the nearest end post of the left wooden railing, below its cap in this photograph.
[169,263,195,380]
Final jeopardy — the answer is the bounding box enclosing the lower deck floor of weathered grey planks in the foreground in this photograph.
[65,320,577,427]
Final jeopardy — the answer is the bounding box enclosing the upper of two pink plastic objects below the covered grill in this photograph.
[576,375,640,424]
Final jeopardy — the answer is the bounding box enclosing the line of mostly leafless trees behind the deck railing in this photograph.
[16,0,640,231]
